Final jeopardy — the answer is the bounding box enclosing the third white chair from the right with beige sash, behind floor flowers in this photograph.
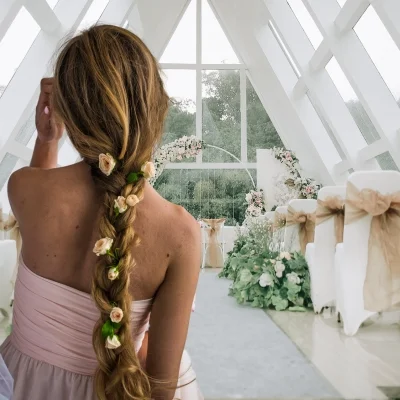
[284,199,317,255]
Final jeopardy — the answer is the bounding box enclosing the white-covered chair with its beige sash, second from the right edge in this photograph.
[306,186,346,313]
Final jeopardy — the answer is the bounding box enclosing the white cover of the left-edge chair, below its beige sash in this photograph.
[0,240,17,316]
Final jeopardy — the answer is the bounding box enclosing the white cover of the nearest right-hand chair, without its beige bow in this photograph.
[335,171,400,336]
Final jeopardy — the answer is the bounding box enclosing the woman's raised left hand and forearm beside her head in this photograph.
[30,78,64,169]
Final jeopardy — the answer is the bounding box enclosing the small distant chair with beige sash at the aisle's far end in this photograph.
[202,218,225,268]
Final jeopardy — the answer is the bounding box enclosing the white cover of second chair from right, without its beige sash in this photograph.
[306,186,346,313]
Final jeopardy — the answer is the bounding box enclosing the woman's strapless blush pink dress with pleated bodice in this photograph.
[0,259,203,400]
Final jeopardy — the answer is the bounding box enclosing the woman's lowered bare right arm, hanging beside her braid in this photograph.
[146,211,201,400]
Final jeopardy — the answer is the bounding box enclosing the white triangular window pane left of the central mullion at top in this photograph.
[160,0,196,64]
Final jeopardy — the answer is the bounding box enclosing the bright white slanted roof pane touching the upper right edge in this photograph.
[354,6,400,103]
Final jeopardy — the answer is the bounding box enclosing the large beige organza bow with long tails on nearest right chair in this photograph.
[345,183,400,312]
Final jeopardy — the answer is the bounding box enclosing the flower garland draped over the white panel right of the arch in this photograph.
[272,147,321,199]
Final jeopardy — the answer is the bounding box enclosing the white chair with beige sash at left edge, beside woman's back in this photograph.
[0,209,22,316]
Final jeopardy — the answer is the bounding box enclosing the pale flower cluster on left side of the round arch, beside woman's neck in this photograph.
[149,135,204,185]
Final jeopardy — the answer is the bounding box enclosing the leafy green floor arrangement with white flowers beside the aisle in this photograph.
[219,214,312,311]
